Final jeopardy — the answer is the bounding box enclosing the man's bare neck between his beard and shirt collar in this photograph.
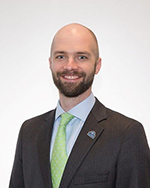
[59,89,91,112]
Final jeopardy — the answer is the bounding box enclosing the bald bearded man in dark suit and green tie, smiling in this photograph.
[10,24,150,188]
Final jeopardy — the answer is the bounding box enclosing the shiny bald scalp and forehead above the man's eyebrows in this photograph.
[51,23,99,60]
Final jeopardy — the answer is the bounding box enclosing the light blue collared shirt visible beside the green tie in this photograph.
[50,93,95,158]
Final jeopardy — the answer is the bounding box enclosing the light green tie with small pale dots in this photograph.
[51,113,74,188]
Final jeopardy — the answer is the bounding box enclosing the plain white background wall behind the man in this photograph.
[0,0,150,188]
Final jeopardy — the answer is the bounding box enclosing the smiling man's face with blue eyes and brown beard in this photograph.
[50,27,100,97]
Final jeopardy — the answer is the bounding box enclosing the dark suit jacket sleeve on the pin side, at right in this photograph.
[116,122,150,188]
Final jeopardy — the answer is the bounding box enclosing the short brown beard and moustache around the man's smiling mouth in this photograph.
[52,66,96,98]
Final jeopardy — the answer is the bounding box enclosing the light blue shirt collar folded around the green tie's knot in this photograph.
[55,93,95,121]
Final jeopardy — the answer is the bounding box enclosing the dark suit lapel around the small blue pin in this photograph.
[60,100,106,188]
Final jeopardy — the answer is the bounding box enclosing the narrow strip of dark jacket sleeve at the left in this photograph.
[9,124,25,188]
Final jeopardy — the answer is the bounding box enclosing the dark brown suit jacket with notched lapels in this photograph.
[9,100,150,188]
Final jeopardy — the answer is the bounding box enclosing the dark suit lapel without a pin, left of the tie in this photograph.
[38,111,55,188]
